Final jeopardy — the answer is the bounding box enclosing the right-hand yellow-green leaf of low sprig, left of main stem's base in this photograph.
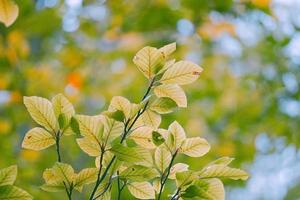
[74,168,99,191]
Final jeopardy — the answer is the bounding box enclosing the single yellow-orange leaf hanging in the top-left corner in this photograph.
[0,0,19,27]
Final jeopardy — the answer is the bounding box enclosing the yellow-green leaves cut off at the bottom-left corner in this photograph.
[0,165,32,200]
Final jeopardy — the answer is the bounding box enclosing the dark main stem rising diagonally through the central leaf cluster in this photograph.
[89,77,155,200]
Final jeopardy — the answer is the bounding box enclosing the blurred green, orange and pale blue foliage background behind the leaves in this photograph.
[0,0,300,200]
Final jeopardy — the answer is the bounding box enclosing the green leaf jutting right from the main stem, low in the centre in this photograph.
[111,144,153,166]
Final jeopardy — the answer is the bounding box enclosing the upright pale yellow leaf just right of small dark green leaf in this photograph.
[168,121,186,150]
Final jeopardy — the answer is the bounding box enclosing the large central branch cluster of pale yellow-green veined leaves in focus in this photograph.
[22,43,248,199]
